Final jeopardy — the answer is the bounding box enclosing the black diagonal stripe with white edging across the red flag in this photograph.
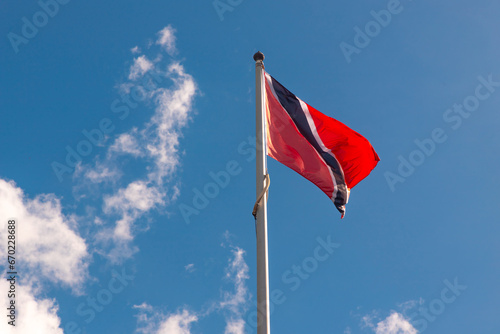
[266,73,348,211]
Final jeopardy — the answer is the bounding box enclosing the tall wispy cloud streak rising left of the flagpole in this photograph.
[75,25,198,262]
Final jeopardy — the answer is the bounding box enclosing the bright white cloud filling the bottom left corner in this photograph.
[0,280,63,334]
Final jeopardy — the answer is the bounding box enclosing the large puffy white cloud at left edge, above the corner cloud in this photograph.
[0,179,89,293]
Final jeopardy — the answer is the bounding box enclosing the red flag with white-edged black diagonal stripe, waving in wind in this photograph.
[264,72,380,218]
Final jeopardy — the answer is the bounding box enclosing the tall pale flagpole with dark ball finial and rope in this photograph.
[253,51,271,334]
